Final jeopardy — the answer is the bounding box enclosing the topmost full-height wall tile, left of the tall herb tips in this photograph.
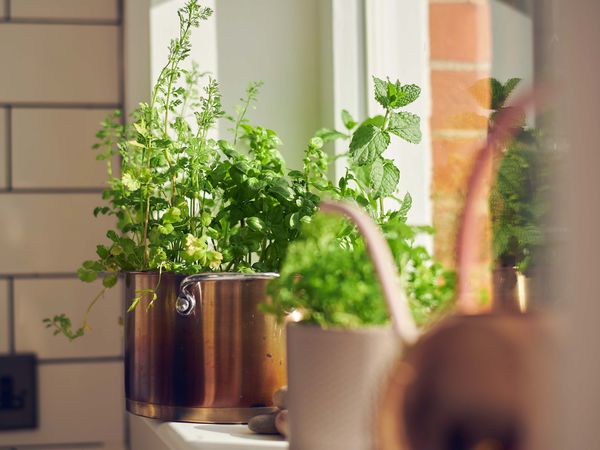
[0,22,120,104]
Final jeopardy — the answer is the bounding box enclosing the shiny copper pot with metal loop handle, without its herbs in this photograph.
[125,272,286,423]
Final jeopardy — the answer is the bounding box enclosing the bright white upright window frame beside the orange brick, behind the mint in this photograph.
[366,0,432,224]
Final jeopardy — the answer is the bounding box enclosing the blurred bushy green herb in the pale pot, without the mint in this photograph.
[263,214,455,328]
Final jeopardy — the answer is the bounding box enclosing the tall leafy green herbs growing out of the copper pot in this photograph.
[78,0,316,284]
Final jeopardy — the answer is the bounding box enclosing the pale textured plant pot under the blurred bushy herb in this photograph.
[287,323,400,450]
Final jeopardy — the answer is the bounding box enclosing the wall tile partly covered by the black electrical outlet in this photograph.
[0,362,124,448]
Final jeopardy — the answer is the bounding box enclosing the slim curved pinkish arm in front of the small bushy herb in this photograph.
[320,200,419,345]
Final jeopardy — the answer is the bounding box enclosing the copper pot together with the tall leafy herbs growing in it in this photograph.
[46,0,319,423]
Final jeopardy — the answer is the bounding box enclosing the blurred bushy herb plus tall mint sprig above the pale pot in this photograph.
[263,78,455,328]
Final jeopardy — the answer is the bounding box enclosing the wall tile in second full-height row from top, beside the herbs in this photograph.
[12,108,111,188]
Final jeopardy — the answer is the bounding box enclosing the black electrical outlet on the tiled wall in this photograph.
[0,354,37,430]
